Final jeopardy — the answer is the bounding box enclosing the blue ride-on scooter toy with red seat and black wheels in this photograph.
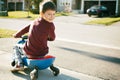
[11,36,60,80]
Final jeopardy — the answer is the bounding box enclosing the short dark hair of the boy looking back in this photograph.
[42,1,56,13]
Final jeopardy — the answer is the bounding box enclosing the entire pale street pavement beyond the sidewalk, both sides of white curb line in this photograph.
[0,16,120,80]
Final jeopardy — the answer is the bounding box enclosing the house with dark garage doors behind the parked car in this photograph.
[57,0,120,15]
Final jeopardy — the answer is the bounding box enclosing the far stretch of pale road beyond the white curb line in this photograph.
[0,15,120,49]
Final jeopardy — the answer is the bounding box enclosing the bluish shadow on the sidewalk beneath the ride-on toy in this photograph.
[13,68,80,80]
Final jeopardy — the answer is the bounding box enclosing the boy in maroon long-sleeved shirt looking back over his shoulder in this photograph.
[12,1,56,71]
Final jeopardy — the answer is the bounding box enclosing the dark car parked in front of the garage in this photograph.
[87,5,109,17]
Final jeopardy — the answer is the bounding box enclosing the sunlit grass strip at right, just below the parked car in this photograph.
[86,17,120,25]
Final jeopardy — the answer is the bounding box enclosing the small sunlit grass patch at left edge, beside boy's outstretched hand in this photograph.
[0,28,16,38]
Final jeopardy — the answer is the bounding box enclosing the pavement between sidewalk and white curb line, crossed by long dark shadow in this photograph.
[0,38,120,80]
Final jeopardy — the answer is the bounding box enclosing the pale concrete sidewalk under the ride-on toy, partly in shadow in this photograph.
[0,51,102,80]
